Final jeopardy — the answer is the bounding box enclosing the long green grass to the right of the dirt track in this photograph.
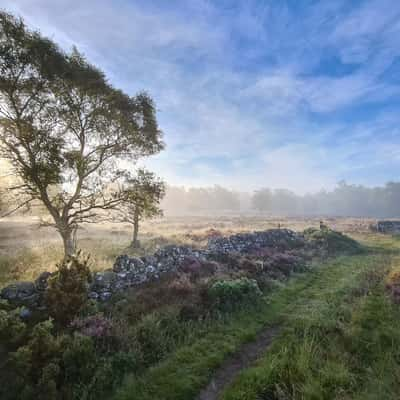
[222,255,400,400]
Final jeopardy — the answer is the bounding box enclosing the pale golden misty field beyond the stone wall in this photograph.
[0,216,373,286]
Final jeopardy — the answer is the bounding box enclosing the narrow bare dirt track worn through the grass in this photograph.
[196,327,279,400]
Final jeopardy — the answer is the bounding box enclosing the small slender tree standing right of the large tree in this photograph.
[117,169,165,248]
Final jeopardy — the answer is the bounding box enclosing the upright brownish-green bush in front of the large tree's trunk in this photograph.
[45,254,91,325]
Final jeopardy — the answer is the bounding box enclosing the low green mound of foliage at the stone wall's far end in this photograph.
[304,228,362,254]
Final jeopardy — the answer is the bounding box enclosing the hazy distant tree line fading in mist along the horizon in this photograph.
[161,181,400,218]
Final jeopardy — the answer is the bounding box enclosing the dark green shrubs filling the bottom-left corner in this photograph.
[0,311,137,400]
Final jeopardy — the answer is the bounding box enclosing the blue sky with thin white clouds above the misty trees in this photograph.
[2,0,400,193]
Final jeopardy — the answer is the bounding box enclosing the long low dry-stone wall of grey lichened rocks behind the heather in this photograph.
[0,229,304,308]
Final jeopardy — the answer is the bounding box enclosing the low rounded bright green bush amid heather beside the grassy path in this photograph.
[208,278,262,312]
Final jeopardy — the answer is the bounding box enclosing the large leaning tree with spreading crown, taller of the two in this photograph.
[0,12,163,257]
